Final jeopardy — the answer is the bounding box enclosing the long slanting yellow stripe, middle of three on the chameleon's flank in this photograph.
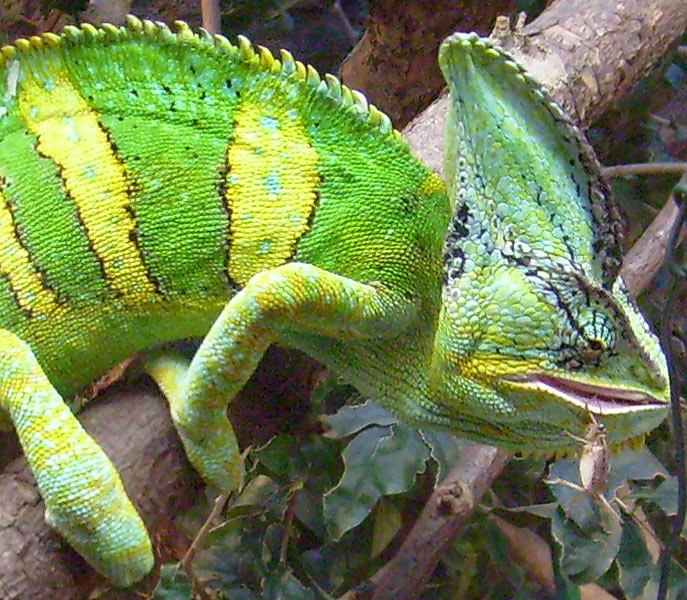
[19,65,155,303]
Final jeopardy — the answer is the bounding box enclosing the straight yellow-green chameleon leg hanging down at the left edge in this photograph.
[0,329,154,587]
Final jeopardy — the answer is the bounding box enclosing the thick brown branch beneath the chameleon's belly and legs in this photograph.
[0,348,321,600]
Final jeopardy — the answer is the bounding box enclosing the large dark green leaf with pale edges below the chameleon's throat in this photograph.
[324,425,429,540]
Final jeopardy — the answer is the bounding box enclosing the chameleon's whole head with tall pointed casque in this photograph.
[426,34,670,451]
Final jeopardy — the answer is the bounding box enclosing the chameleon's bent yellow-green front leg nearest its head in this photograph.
[144,263,416,493]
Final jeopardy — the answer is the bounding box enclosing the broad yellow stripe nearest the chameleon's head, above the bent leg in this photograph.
[225,102,320,285]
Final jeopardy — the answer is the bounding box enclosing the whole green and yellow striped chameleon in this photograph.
[0,17,669,586]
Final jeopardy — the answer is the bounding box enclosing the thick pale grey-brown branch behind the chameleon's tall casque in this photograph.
[405,0,687,171]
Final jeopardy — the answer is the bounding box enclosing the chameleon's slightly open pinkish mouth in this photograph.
[503,374,665,415]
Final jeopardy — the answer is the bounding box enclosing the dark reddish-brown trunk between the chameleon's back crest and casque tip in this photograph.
[340,0,515,128]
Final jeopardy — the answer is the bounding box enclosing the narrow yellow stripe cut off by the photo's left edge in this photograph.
[0,190,64,318]
